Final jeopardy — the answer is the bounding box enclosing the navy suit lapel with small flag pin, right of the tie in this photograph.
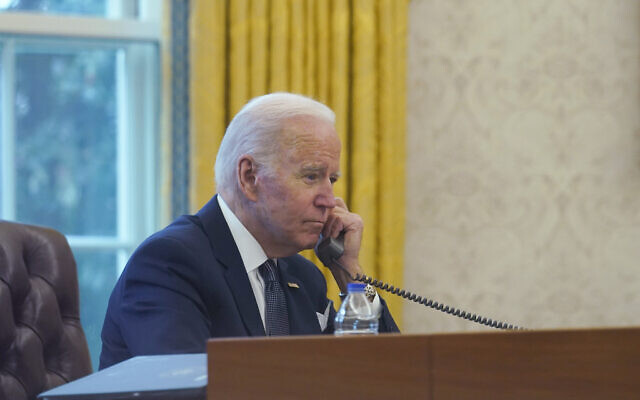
[278,258,324,335]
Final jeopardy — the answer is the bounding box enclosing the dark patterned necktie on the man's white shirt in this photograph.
[258,260,289,336]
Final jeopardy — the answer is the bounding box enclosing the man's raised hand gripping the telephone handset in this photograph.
[322,197,364,293]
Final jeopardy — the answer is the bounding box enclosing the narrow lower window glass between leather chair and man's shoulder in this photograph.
[74,250,118,371]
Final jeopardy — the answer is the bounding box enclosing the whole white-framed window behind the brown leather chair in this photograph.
[0,0,160,369]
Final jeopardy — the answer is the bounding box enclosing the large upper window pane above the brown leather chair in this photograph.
[14,47,117,236]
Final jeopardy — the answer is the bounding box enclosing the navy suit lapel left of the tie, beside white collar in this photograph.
[197,195,265,336]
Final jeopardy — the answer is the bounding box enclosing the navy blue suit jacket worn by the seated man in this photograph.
[100,196,398,369]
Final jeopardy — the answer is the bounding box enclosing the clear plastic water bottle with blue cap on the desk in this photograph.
[334,283,380,336]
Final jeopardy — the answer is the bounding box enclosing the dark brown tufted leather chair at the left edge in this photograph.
[0,221,91,400]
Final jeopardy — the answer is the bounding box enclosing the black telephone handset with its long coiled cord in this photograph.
[315,232,523,330]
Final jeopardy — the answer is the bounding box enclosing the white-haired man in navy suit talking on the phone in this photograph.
[100,93,398,368]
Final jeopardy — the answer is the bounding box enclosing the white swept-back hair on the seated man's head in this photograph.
[215,92,335,192]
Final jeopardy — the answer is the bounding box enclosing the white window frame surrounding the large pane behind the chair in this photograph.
[0,0,164,274]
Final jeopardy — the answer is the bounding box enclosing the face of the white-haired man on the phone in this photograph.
[256,117,340,257]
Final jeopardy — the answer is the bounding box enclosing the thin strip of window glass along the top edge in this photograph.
[0,0,109,16]
